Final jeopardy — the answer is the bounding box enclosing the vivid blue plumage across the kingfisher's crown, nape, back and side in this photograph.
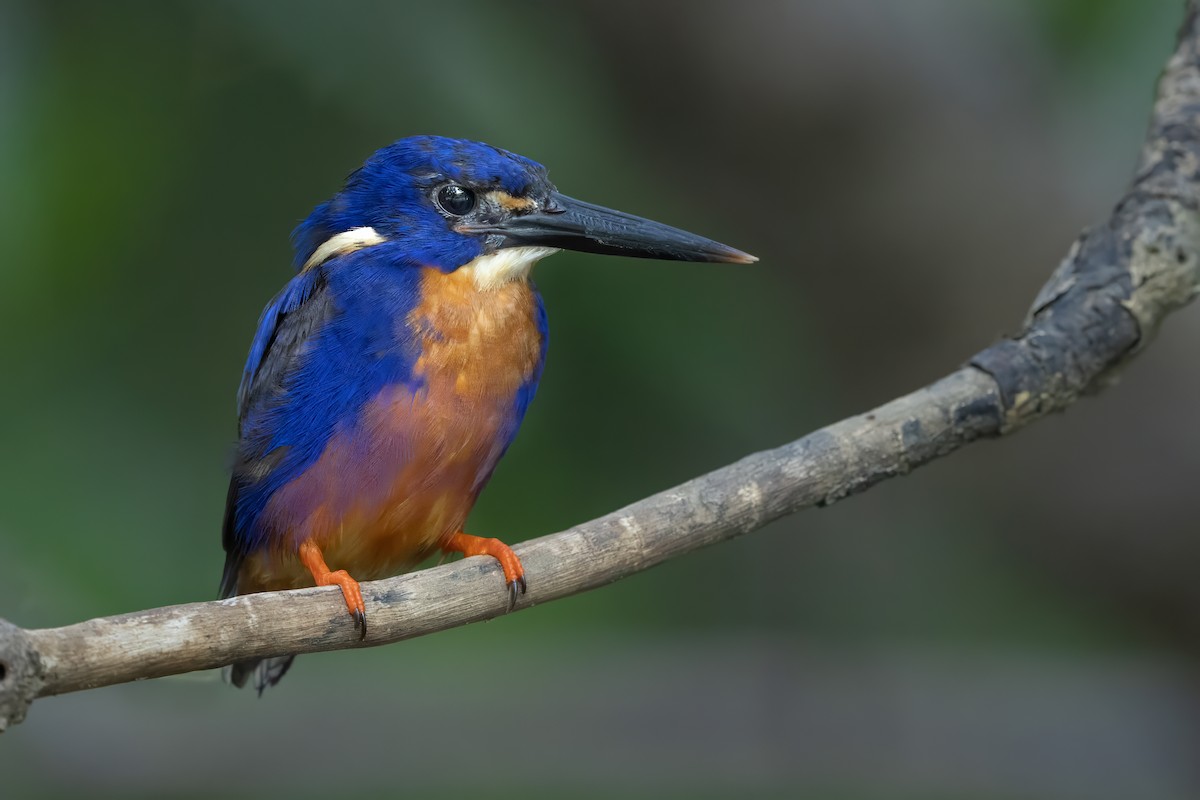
[227,137,550,568]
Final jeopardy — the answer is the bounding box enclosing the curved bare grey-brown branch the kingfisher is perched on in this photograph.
[0,0,1200,730]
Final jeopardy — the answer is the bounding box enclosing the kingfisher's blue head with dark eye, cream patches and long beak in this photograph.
[293,136,757,283]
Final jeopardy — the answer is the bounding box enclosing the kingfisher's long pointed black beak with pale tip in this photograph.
[475,192,758,264]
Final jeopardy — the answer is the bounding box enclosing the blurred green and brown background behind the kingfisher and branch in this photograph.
[0,0,1200,800]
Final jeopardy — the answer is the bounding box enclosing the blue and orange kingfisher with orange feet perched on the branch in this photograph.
[220,136,757,693]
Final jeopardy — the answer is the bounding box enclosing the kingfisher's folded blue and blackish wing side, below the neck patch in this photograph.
[221,251,420,596]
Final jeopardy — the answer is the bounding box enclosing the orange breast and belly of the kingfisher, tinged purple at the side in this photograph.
[242,269,542,591]
